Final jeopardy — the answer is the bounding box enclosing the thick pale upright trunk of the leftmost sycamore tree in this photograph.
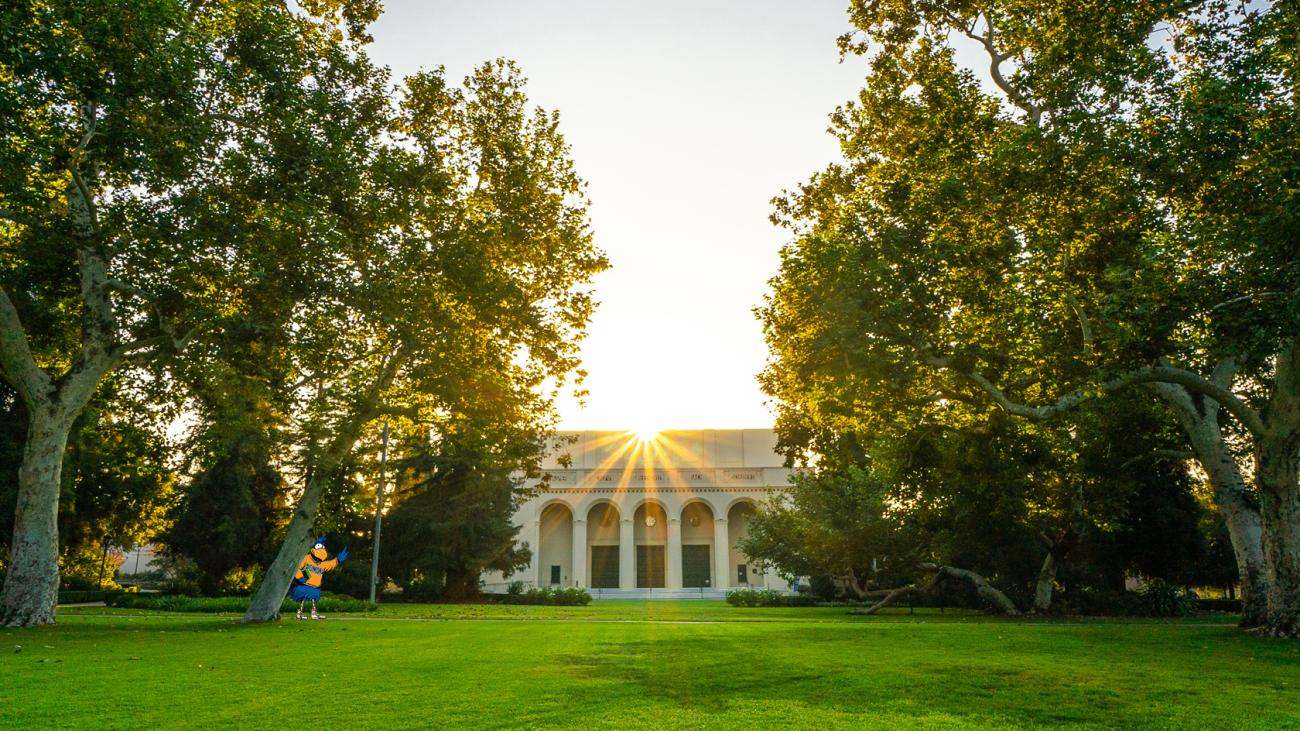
[0,407,72,627]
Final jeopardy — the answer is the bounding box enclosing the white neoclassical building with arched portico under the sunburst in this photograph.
[484,429,790,598]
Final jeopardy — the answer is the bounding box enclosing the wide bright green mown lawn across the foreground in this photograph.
[0,602,1300,728]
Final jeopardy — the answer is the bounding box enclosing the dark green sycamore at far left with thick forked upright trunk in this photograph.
[0,0,392,626]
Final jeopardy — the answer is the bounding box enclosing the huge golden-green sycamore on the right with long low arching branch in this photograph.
[759,0,1300,636]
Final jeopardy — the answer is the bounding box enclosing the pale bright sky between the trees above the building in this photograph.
[371,0,866,429]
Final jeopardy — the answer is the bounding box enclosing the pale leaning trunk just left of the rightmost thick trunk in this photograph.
[1151,377,1270,627]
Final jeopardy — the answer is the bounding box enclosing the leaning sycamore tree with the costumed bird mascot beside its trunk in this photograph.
[244,61,607,622]
